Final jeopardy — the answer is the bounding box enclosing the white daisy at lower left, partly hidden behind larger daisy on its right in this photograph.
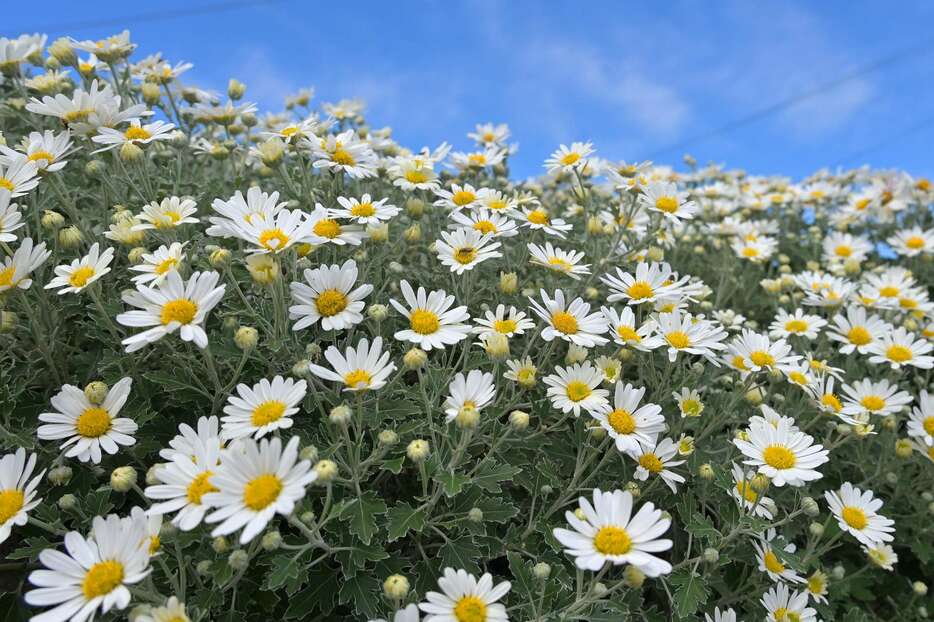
[145,432,221,531]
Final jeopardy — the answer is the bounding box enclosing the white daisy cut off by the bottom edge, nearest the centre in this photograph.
[418,568,512,622]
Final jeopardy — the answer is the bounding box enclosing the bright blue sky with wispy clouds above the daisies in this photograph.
[3,0,934,178]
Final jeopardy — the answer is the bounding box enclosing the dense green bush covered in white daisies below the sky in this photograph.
[0,33,934,622]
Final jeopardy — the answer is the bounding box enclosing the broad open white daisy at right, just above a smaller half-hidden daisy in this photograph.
[733,419,830,486]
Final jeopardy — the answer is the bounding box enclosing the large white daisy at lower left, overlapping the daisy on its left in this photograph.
[202,436,318,544]
